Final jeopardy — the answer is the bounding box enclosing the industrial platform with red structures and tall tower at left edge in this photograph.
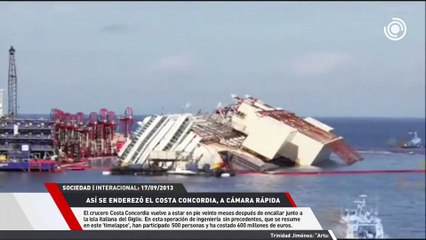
[0,46,133,170]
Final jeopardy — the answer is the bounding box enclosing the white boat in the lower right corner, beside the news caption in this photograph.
[340,194,385,239]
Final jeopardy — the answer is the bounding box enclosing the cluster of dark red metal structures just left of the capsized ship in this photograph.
[51,107,133,161]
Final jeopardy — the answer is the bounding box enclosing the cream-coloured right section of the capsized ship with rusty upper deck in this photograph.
[222,96,361,165]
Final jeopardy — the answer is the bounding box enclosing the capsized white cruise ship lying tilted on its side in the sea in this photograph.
[118,95,362,171]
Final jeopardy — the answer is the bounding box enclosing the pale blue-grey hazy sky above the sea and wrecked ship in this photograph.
[0,2,425,118]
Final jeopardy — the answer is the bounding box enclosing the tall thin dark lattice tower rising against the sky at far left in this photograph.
[8,46,18,117]
